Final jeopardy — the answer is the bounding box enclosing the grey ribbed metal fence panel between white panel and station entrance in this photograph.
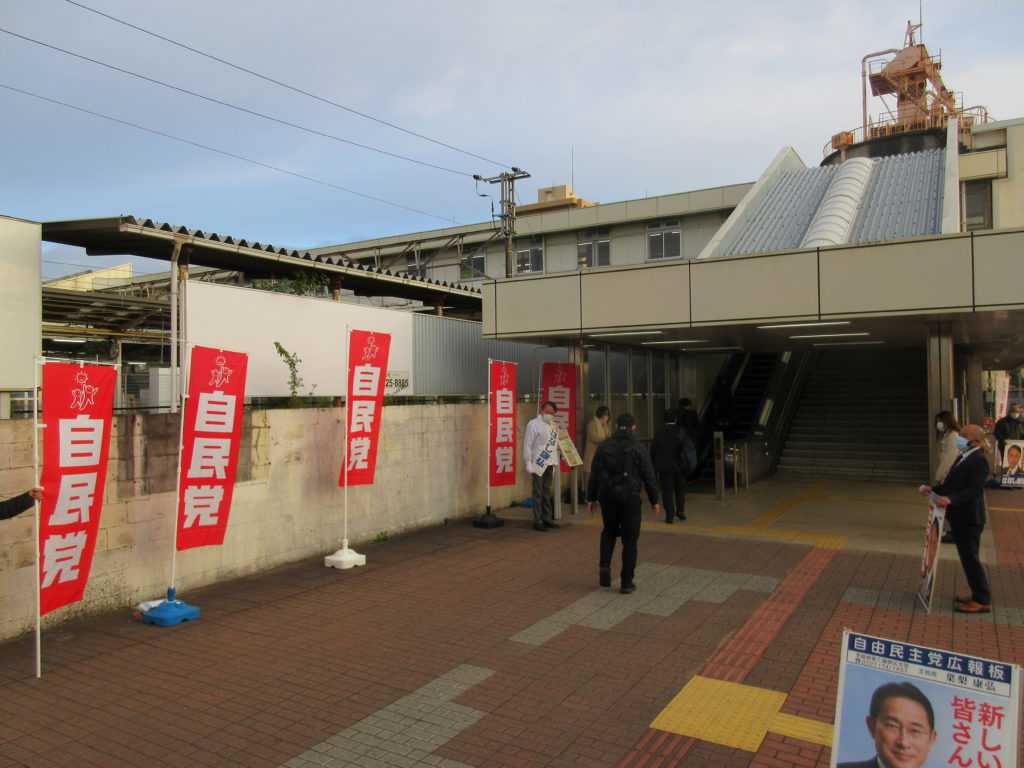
[413,314,545,395]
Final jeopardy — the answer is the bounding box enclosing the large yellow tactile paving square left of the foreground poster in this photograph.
[650,676,785,752]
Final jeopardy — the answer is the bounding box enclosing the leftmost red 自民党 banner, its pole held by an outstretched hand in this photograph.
[39,362,118,615]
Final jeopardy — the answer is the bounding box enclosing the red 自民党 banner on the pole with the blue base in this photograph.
[177,347,249,551]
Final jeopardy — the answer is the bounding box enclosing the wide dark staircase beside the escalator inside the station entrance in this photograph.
[777,349,931,483]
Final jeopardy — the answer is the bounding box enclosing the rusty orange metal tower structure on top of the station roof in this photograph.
[824,22,988,157]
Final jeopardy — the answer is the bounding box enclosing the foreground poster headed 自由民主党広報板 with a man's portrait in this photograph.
[829,631,1020,768]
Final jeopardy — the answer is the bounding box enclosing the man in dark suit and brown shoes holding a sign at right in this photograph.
[921,424,992,613]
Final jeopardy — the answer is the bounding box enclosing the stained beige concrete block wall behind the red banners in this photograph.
[0,403,535,640]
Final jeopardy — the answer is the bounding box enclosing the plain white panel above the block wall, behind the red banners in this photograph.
[186,282,413,397]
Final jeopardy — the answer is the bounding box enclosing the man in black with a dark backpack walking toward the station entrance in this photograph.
[587,414,662,595]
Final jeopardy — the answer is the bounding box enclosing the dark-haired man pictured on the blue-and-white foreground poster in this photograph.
[839,683,937,768]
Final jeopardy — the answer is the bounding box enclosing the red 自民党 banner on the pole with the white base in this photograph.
[338,330,391,485]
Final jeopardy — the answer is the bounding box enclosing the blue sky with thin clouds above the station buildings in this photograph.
[0,0,1024,278]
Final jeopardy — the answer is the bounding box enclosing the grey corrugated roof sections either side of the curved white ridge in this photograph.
[715,150,945,256]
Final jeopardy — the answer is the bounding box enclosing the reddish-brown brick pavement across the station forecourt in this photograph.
[0,501,1024,768]
